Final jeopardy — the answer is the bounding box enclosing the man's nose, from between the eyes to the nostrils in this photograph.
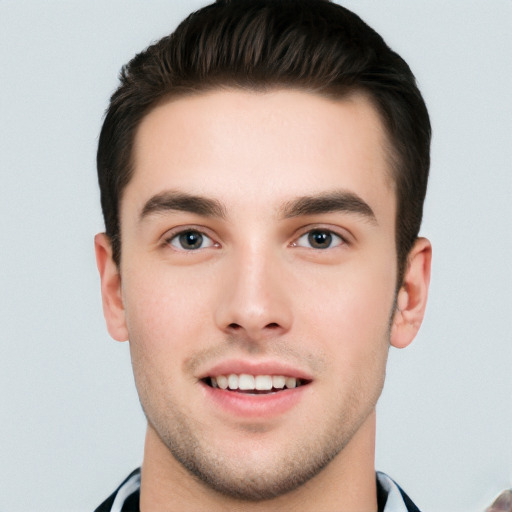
[215,248,292,342]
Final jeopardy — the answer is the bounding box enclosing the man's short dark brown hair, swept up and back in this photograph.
[97,0,431,284]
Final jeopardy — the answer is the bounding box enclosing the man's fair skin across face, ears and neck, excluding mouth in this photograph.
[96,90,431,511]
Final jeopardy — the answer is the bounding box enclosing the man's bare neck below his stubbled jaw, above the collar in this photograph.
[140,411,377,512]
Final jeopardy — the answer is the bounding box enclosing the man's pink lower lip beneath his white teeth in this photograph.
[201,382,311,419]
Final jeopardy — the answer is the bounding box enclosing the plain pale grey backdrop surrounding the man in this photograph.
[0,0,512,512]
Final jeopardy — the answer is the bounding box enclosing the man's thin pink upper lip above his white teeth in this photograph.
[199,359,313,380]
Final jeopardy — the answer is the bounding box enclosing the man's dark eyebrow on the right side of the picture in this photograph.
[280,190,377,224]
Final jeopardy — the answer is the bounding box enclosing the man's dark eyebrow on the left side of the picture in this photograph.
[139,191,226,220]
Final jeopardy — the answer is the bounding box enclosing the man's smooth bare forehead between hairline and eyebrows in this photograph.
[125,90,394,222]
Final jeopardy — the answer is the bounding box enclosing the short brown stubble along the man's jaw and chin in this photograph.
[138,356,384,502]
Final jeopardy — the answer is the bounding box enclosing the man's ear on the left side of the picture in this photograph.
[94,233,128,341]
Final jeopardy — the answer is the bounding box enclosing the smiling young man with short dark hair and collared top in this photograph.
[95,0,431,512]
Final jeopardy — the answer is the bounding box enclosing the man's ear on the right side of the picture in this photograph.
[391,238,432,348]
